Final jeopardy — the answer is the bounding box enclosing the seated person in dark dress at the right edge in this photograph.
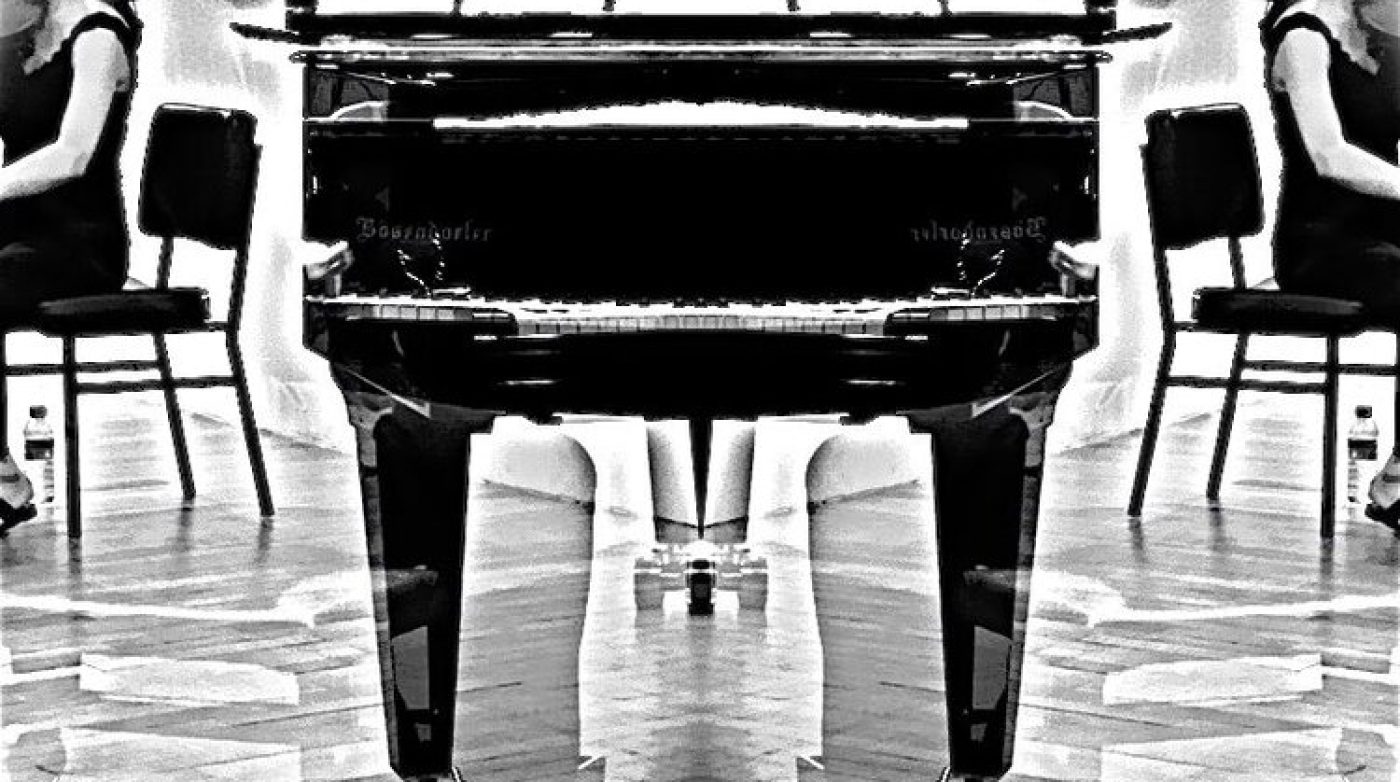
[1261,0,1400,530]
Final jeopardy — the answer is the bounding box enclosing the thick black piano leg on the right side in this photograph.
[909,386,1064,779]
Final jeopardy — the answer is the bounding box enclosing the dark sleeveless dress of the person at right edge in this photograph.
[1263,11,1400,313]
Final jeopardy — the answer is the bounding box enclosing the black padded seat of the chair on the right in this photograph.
[1191,288,1369,334]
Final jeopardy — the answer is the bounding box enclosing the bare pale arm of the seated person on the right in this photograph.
[1273,29,1400,200]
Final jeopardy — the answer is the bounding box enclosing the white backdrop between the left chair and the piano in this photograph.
[123,0,351,448]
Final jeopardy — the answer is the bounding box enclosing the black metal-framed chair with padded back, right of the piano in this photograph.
[1128,104,1394,537]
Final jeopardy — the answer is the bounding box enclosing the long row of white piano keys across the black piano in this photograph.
[308,291,1093,336]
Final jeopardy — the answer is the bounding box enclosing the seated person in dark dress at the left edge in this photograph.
[0,0,140,533]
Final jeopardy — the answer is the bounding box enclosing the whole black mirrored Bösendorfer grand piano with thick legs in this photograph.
[238,0,1156,779]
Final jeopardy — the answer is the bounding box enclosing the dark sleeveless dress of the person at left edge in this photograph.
[0,13,139,294]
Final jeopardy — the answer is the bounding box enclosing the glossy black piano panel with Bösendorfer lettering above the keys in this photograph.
[305,120,1099,301]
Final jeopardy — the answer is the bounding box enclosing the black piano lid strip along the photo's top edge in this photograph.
[270,0,1117,45]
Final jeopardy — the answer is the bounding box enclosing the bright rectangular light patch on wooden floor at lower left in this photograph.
[78,655,301,705]
